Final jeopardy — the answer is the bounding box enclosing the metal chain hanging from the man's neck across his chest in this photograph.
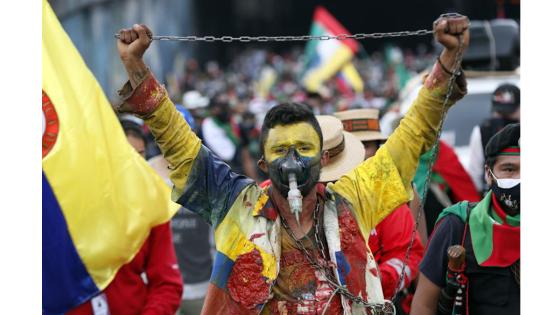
[280,202,396,315]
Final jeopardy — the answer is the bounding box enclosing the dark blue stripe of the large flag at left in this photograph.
[43,173,99,314]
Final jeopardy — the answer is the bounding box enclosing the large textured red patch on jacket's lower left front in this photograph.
[227,249,269,309]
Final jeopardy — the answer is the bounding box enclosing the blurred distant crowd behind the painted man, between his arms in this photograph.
[137,45,434,181]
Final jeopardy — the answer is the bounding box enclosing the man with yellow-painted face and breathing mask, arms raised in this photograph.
[117,16,469,314]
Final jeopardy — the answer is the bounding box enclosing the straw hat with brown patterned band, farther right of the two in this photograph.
[334,108,387,141]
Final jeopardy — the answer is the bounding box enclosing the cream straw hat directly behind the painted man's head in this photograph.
[316,115,366,183]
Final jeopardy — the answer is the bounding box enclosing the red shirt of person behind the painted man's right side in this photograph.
[368,204,424,299]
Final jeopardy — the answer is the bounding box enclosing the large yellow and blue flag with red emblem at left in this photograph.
[42,0,178,314]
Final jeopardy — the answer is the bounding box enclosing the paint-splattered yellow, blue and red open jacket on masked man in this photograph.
[121,64,466,314]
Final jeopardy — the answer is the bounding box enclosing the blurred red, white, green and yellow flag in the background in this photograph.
[303,6,363,92]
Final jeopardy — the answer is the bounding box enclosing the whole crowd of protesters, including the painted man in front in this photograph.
[69,17,520,315]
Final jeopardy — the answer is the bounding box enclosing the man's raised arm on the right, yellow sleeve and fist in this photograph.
[331,16,469,232]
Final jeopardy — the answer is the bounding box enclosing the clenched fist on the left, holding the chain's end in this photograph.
[117,24,152,64]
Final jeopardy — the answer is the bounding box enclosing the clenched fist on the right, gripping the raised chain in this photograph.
[434,13,470,51]
